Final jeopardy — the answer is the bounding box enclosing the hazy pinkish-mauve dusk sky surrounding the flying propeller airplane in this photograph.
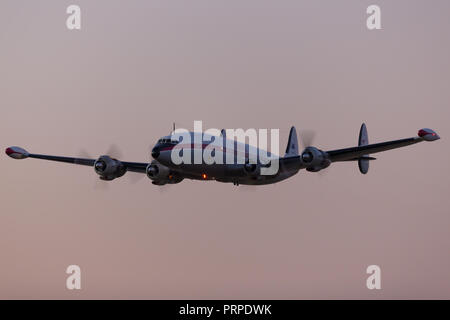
[0,0,450,299]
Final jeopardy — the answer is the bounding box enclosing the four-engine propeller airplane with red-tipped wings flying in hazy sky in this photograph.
[5,123,440,186]
